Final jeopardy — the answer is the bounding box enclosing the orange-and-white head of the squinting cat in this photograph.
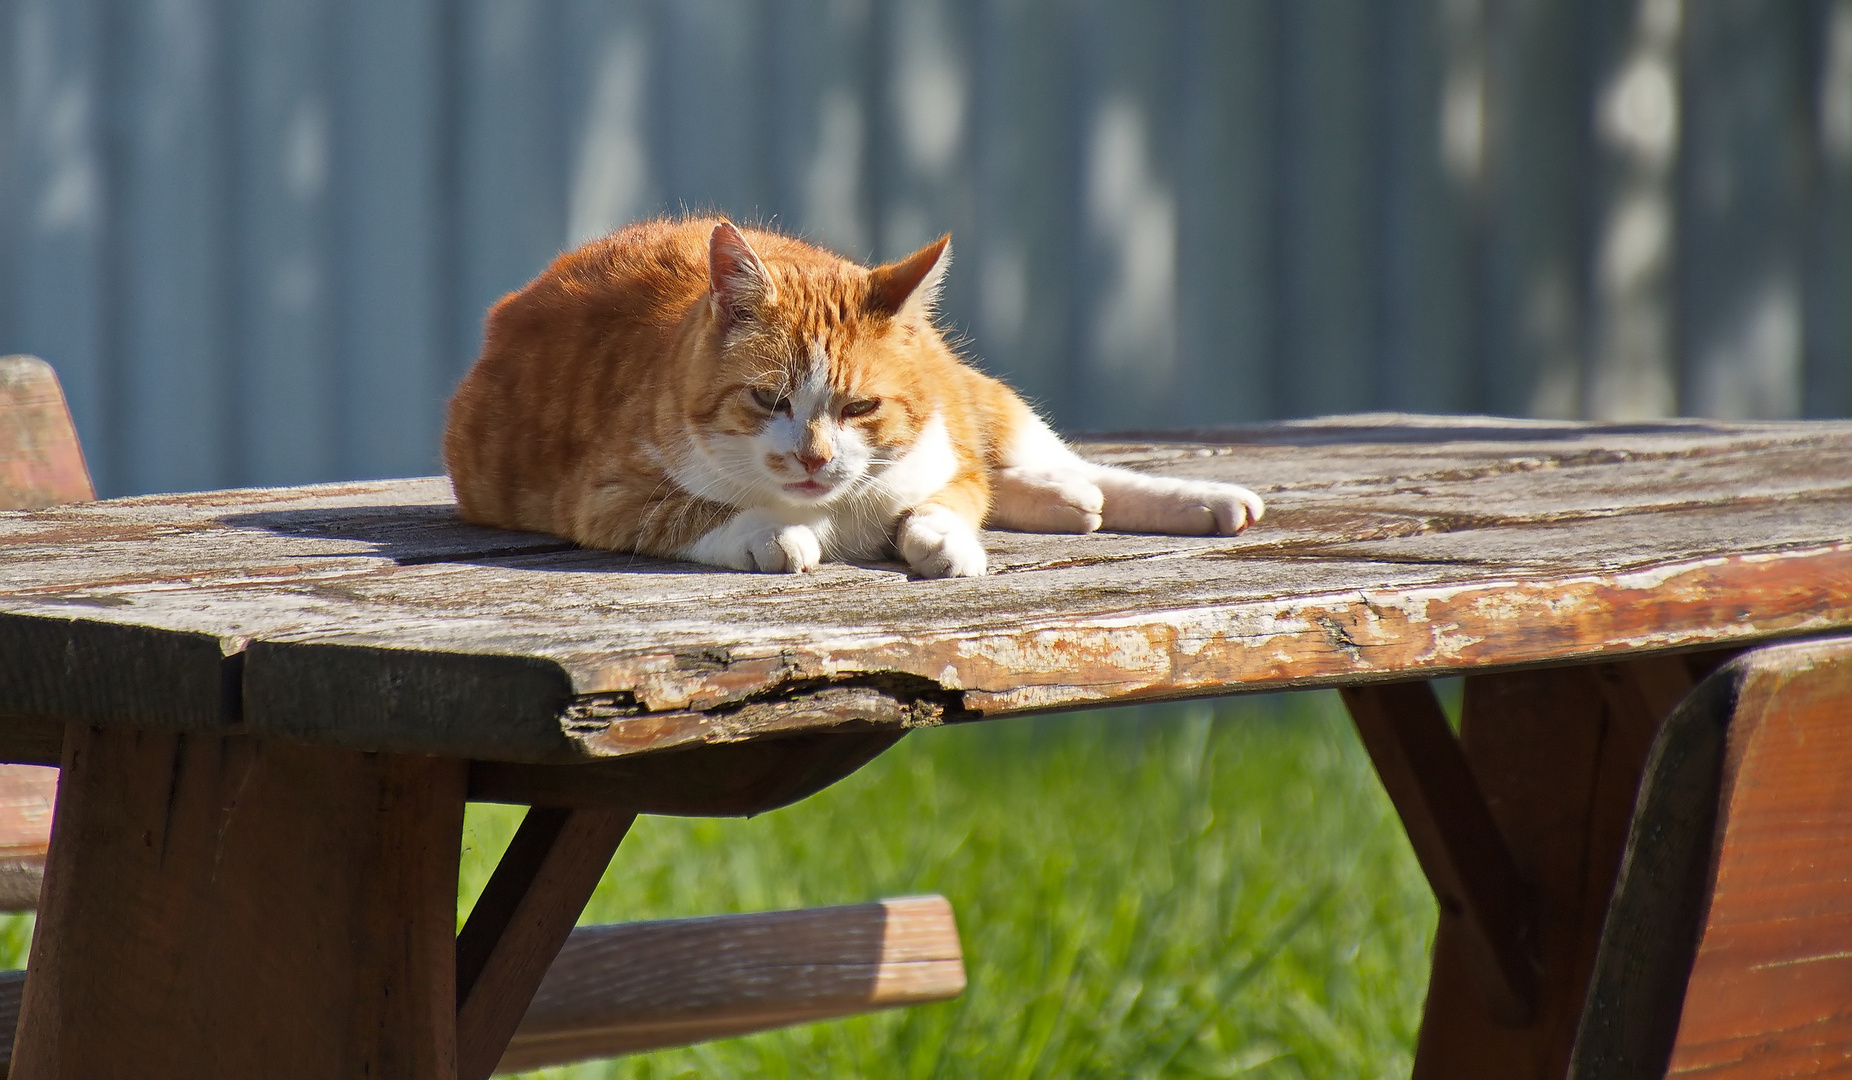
[689,222,950,515]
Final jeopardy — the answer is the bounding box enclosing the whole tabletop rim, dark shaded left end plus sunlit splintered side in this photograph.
[0,543,1852,765]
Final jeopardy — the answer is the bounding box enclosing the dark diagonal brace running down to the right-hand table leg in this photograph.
[1343,682,1537,1026]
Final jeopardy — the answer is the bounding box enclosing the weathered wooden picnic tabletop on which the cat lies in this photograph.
[0,417,1852,761]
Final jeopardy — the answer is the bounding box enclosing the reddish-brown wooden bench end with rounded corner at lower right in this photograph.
[1570,637,1852,1080]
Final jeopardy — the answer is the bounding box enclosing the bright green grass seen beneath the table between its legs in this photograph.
[461,693,1435,1080]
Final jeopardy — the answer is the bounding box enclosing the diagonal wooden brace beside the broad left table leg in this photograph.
[456,806,637,1080]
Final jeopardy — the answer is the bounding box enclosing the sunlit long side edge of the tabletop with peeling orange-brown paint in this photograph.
[548,543,1852,758]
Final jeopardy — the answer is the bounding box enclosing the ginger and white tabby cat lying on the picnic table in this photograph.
[444,219,1263,578]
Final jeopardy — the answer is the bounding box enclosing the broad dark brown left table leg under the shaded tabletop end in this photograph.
[13,726,465,1080]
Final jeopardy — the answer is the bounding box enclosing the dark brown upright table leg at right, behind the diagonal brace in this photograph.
[1413,658,1691,1080]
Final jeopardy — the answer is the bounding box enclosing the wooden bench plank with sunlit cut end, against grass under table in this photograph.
[492,897,965,1073]
